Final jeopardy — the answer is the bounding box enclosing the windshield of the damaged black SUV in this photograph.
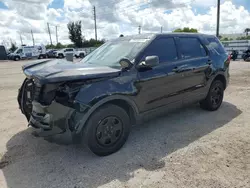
[81,39,148,68]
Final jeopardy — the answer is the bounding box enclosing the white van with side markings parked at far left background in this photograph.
[8,45,46,61]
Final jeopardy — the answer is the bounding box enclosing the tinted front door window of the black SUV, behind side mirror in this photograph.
[143,38,178,63]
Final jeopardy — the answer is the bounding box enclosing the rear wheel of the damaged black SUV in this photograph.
[200,80,225,111]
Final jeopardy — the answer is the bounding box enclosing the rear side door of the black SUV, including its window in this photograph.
[177,36,211,103]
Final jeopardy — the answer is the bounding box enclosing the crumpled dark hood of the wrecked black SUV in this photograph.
[22,59,121,83]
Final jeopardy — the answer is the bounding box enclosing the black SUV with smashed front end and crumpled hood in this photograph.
[18,33,230,156]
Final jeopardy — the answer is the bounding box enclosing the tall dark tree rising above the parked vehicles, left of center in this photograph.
[68,21,83,48]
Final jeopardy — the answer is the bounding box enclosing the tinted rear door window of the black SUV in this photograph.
[180,38,207,59]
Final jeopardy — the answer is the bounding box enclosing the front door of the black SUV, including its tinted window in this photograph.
[136,36,188,113]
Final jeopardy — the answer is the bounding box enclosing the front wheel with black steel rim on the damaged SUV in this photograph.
[83,104,131,156]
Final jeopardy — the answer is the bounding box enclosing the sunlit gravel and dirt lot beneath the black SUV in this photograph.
[0,61,250,188]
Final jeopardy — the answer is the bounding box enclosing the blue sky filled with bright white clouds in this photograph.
[0,0,250,45]
